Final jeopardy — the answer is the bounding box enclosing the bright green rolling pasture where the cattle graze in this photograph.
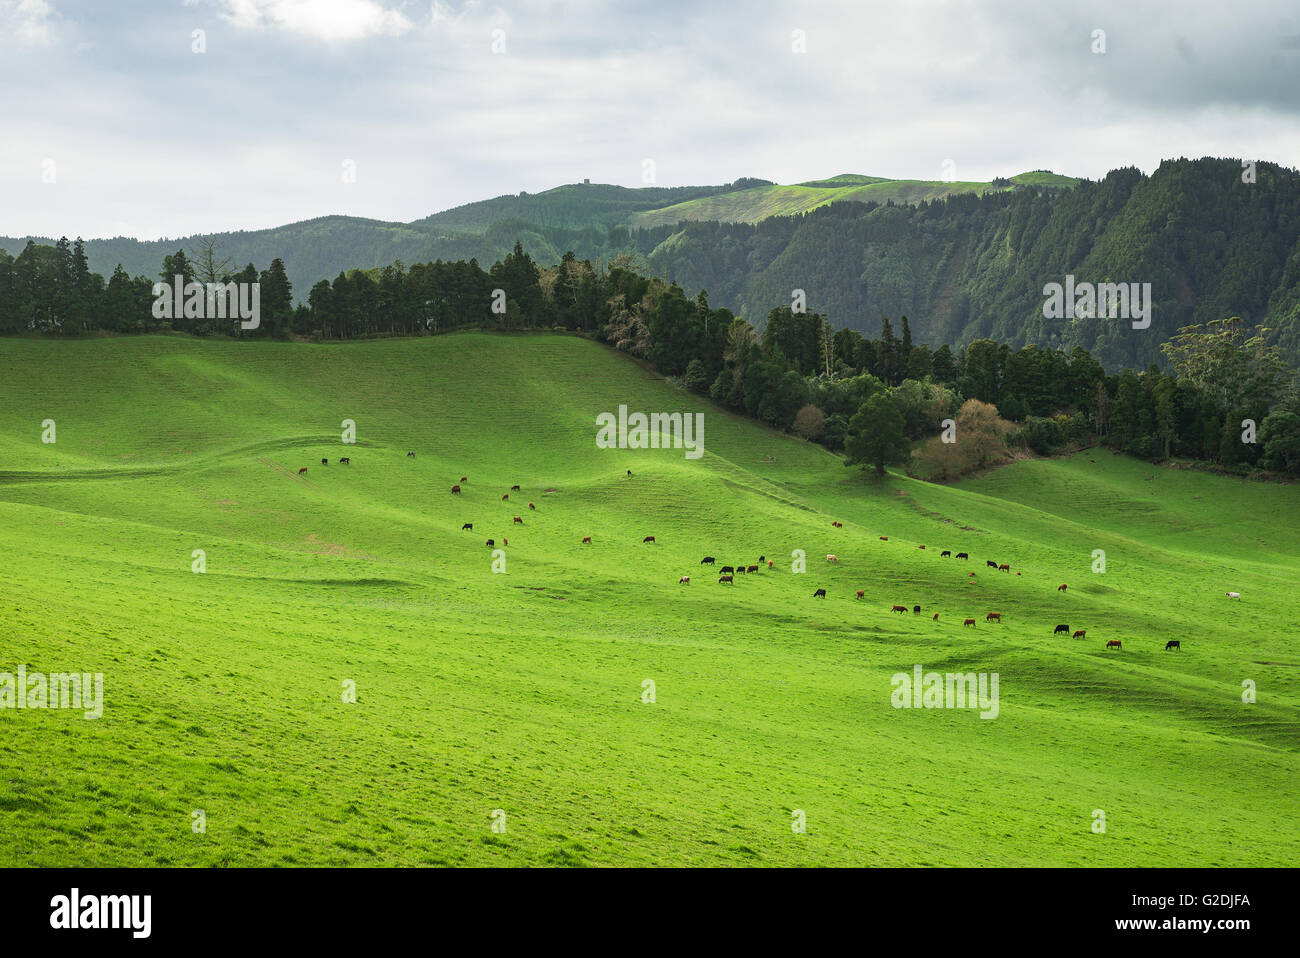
[0,334,1300,866]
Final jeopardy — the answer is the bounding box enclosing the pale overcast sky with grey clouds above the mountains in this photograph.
[0,0,1300,239]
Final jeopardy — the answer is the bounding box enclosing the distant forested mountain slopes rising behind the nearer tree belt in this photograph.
[10,159,1300,370]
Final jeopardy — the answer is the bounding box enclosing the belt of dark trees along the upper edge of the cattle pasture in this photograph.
[0,239,1300,478]
